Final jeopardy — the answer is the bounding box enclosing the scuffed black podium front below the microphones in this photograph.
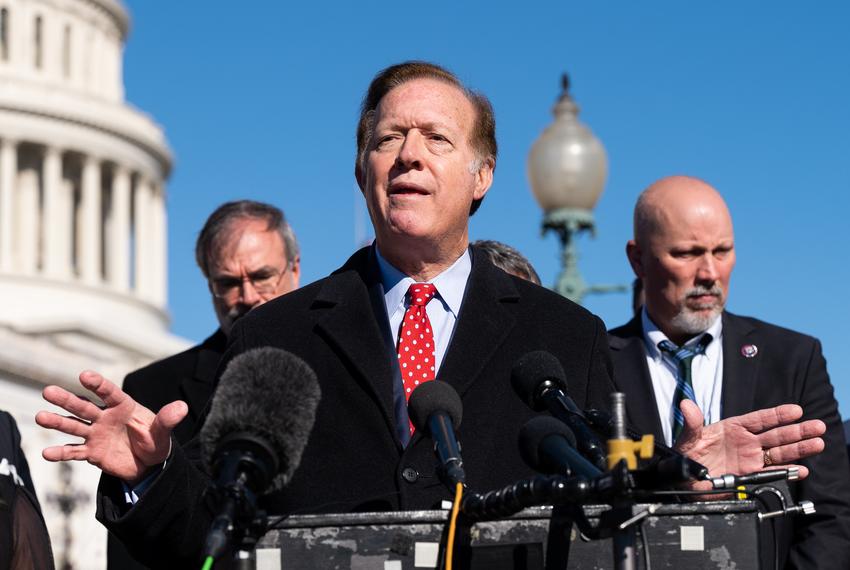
[240,501,759,570]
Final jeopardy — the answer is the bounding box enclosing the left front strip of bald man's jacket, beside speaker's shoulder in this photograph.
[608,316,664,442]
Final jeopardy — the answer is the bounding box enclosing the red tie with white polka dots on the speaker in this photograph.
[398,283,437,433]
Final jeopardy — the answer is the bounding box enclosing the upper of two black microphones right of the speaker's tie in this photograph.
[511,350,608,470]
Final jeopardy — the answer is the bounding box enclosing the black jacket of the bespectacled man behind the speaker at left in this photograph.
[106,329,227,570]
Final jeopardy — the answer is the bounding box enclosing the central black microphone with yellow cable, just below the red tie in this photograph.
[407,380,466,486]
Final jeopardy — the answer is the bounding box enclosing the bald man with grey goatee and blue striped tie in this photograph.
[609,176,850,568]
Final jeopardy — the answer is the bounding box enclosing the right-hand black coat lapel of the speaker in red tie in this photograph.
[437,248,519,396]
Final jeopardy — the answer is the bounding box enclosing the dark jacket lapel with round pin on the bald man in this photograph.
[720,312,761,418]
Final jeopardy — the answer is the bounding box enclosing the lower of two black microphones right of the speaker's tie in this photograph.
[519,416,602,479]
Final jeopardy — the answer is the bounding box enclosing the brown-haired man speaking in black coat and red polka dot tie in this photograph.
[37,62,821,563]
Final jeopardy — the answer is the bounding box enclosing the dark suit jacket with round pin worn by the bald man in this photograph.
[608,312,850,568]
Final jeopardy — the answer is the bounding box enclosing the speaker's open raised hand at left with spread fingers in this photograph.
[35,370,189,483]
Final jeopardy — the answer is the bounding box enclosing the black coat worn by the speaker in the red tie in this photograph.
[98,243,612,564]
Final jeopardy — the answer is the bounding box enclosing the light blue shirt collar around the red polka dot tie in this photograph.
[375,244,472,318]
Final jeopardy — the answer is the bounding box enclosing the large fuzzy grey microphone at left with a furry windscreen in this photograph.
[200,347,321,558]
